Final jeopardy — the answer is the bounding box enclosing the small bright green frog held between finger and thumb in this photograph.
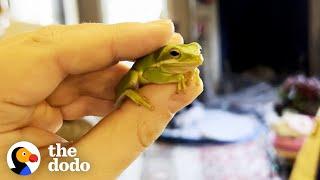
[115,42,203,110]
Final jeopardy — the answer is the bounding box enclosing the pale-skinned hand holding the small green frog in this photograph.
[0,21,203,179]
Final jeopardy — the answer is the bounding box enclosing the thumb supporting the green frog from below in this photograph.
[67,70,203,179]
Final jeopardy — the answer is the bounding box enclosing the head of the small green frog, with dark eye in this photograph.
[156,42,203,73]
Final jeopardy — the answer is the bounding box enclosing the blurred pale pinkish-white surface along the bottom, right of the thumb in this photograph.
[136,140,275,180]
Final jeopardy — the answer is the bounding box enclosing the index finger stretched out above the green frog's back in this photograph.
[31,20,174,74]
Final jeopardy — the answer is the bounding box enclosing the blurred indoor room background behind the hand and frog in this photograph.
[0,0,320,180]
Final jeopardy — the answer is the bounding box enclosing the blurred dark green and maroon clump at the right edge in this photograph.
[276,75,320,116]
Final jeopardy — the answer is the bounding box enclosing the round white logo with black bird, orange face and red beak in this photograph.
[7,141,41,176]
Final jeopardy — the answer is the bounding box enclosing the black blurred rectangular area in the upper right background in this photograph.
[220,0,309,77]
